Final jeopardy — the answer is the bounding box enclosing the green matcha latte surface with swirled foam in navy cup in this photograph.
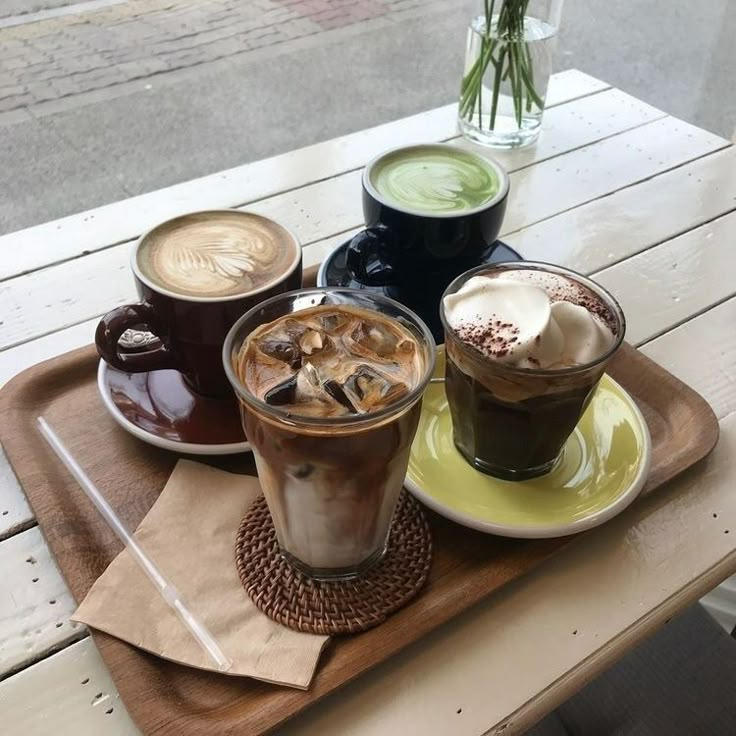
[369,145,501,216]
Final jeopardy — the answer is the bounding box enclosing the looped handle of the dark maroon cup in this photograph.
[95,302,179,373]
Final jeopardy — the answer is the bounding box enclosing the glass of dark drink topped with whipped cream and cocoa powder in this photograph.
[440,261,626,480]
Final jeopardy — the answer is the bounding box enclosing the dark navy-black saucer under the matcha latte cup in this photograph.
[317,240,523,343]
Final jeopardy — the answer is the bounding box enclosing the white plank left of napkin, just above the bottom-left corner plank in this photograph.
[0,527,84,675]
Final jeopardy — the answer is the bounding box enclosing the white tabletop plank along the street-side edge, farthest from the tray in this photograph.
[0,70,608,279]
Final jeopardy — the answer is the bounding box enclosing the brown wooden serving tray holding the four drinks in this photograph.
[0,334,718,736]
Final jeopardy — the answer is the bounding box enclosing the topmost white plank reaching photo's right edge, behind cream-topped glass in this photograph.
[505,146,736,273]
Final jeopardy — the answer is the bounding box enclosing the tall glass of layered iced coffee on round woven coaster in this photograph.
[223,289,435,579]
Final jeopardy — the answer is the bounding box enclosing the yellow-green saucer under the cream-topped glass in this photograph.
[406,347,651,538]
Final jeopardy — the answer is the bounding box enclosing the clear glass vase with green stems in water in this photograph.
[458,0,564,148]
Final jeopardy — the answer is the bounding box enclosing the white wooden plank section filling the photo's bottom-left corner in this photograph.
[0,638,140,736]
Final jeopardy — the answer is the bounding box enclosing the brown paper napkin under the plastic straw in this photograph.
[72,460,328,689]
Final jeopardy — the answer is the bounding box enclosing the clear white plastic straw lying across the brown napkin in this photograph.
[38,417,232,672]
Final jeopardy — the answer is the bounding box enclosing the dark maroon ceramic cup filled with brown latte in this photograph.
[95,210,302,396]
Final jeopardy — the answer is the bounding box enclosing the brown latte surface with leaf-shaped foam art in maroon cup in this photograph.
[136,211,299,298]
